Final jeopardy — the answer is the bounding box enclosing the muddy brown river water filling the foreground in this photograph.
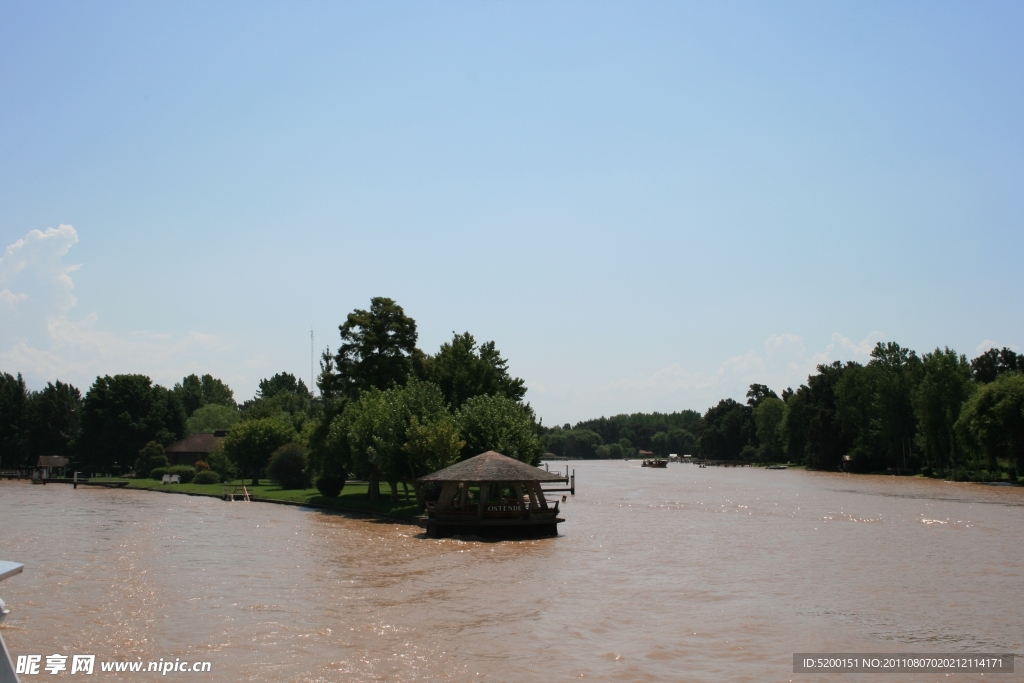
[0,462,1024,683]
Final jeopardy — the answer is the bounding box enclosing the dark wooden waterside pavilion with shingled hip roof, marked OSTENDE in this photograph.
[418,451,566,539]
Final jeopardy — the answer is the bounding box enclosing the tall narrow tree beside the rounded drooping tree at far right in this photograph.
[913,347,975,470]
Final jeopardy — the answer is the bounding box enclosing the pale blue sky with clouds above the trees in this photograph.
[0,0,1024,425]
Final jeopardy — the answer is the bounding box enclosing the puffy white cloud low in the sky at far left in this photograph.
[0,225,231,389]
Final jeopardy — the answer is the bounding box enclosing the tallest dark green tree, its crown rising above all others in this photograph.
[334,297,417,398]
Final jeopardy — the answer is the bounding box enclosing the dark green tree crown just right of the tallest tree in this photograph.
[419,332,526,410]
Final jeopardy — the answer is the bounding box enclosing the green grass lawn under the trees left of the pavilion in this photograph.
[120,479,420,517]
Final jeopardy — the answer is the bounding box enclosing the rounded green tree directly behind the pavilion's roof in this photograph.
[456,395,544,464]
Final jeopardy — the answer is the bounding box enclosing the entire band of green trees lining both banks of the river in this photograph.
[0,331,1024,485]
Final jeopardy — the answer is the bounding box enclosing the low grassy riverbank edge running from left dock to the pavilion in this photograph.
[77,479,420,524]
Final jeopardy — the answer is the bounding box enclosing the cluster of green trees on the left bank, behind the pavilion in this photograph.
[0,297,543,500]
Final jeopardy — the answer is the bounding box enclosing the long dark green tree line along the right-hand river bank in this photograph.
[542,342,1024,480]
